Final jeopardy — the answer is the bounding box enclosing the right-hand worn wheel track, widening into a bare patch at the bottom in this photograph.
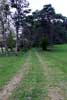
[36,52,65,100]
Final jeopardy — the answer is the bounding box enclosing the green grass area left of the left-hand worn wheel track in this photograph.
[0,52,27,89]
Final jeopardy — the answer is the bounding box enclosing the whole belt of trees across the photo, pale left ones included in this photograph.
[0,0,67,55]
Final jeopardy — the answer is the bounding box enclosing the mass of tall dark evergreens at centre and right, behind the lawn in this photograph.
[27,4,67,45]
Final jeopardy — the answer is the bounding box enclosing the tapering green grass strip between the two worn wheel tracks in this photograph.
[9,51,47,100]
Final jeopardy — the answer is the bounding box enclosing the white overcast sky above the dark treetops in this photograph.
[28,0,67,16]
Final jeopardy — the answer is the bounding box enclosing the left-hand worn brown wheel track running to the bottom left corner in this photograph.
[0,58,29,100]
